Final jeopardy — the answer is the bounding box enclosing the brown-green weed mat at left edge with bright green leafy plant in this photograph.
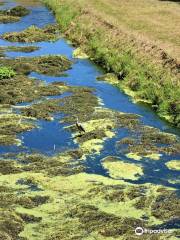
[0,56,71,104]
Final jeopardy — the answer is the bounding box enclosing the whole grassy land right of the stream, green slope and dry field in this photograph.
[44,0,180,126]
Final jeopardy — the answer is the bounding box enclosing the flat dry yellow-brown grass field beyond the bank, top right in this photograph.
[77,0,180,60]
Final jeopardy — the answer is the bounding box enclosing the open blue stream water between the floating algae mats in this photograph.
[0,0,180,189]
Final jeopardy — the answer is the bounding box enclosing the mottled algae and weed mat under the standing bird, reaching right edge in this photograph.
[21,83,180,163]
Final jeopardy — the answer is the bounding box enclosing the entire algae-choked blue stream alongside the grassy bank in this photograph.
[0,0,180,240]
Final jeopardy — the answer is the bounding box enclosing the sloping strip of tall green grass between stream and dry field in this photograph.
[44,0,180,127]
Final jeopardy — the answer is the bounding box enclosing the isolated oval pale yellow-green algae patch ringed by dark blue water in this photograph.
[102,157,143,180]
